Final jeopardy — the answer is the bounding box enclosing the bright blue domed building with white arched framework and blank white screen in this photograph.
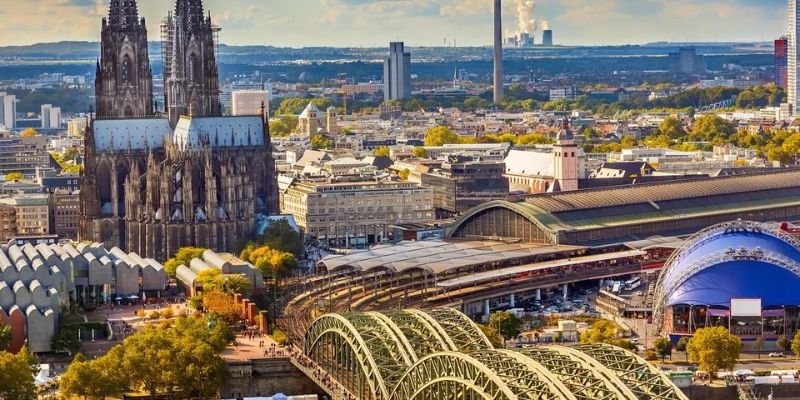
[654,221,800,341]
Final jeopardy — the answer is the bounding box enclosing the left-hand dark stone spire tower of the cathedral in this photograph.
[95,0,153,119]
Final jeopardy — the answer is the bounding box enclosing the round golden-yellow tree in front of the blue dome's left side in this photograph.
[686,326,742,377]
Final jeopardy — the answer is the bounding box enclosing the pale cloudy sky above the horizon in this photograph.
[0,0,787,47]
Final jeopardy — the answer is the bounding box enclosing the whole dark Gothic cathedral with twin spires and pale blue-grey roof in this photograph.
[80,0,278,261]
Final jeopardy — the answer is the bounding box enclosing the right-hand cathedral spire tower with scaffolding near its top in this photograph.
[162,0,221,128]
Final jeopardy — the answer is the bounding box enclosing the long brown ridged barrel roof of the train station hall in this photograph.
[515,169,800,231]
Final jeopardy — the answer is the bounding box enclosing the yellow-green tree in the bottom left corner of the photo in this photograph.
[0,347,39,400]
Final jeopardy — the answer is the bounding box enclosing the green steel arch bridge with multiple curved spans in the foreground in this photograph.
[304,308,687,400]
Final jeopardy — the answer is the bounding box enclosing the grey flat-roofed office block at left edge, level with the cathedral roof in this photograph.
[0,136,50,179]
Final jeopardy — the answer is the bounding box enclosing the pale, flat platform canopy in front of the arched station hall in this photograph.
[321,240,584,274]
